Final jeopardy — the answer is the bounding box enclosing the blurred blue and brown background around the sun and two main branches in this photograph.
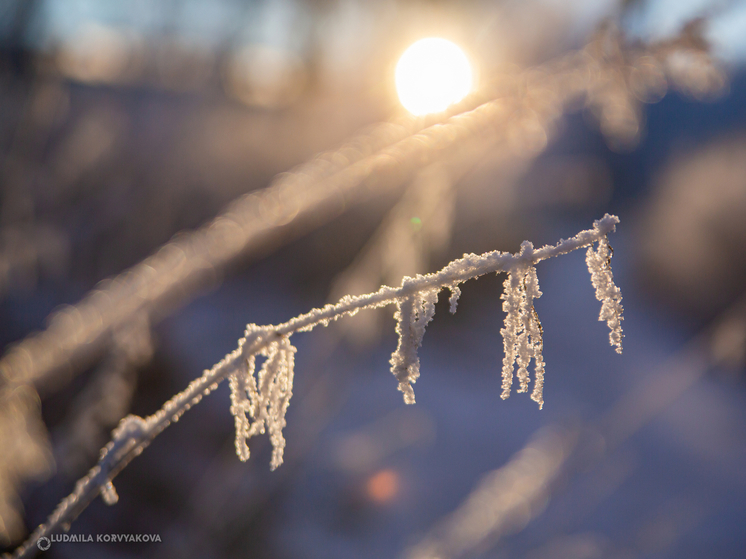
[0,0,746,559]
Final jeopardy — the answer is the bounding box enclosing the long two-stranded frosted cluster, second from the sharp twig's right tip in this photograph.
[500,242,544,408]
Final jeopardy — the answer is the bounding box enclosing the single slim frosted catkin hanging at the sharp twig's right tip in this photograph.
[585,235,624,353]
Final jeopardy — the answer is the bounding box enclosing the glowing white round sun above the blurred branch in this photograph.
[395,37,474,115]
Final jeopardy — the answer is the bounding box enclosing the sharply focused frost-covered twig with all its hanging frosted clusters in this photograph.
[8,214,621,558]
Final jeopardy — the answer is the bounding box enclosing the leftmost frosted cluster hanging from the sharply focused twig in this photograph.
[229,324,296,470]
